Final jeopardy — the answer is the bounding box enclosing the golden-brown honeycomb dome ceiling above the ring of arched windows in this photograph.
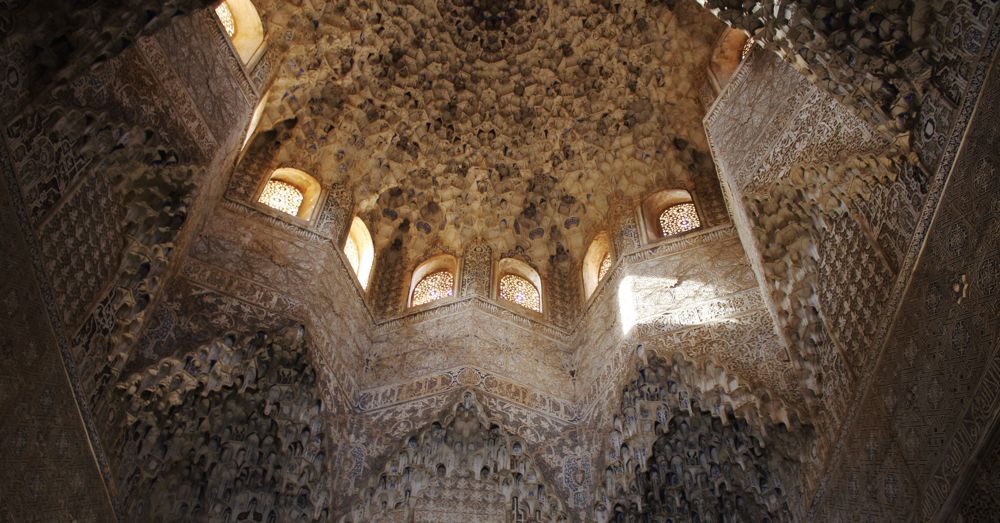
[252,0,722,269]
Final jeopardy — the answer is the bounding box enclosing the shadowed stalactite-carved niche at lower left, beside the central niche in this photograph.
[120,327,331,522]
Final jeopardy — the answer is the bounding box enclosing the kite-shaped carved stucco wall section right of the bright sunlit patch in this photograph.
[706,46,940,482]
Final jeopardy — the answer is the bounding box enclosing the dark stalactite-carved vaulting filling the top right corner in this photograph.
[698,0,996,170]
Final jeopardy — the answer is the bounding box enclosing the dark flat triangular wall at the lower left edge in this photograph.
[0,150,113,521]
